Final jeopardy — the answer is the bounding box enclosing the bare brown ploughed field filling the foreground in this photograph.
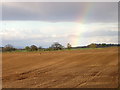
[2,47,118,88]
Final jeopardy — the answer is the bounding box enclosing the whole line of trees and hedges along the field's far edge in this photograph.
[0,42,120,52]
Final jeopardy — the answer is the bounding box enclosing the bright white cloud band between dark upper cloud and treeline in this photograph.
[0,21,118,47]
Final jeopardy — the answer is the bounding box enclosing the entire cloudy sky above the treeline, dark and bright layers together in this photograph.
[0,2,118,47]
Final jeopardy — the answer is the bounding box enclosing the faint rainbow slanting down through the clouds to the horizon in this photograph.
[70,3,93,46]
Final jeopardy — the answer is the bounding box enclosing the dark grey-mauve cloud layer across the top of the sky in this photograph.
[2,2,118,22]
